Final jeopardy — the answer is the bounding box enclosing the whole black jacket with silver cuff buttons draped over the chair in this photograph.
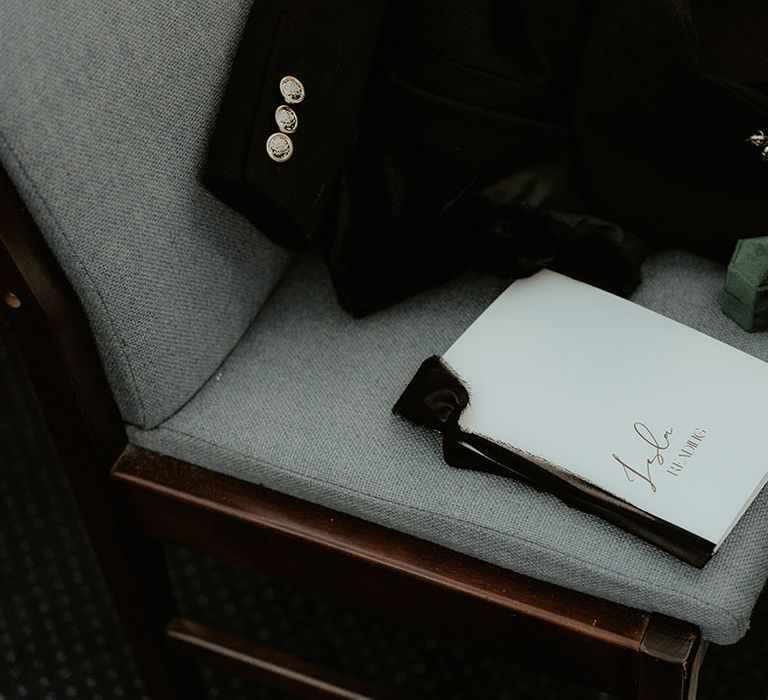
[204,0,768,315]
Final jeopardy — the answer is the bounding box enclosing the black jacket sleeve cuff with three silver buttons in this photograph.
[203,0,385,248]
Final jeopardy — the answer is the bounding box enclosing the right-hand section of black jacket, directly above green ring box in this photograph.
[574,0,768,262]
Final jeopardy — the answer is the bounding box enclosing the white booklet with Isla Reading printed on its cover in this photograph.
[443,270,768,564]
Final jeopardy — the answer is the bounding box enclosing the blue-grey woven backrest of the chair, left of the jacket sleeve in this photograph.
[0,0,289,426]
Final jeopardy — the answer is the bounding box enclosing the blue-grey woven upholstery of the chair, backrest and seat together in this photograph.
[0,0,768,643]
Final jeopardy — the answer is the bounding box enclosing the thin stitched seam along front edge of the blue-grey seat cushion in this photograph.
[142,425,749,628]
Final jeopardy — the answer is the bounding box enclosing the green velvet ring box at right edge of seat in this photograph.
[722,236,768,332]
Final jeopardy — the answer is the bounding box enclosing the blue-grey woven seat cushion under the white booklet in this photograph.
[130,253,768,643]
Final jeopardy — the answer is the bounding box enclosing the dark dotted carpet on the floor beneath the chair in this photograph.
[0,327,768,700]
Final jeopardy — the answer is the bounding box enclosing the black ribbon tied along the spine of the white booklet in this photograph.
[392,356,714,568]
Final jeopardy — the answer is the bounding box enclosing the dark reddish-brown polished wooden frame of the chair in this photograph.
[0,165,706,700]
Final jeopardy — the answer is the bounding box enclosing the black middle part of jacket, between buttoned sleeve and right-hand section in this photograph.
[325,0,648,315]
